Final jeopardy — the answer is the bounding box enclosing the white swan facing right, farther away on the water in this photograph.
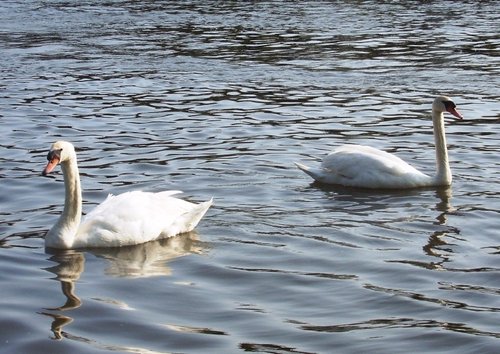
[295,96,463,189]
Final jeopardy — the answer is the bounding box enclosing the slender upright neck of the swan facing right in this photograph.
[432,110,451,186]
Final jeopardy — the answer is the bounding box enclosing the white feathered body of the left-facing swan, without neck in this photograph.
[74,191,212,247]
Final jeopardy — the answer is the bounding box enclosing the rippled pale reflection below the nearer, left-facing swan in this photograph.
[41,231,206,339]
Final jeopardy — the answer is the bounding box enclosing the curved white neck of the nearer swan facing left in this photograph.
[45,158,82,248]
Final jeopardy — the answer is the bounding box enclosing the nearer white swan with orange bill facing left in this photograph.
[42,141,212,249]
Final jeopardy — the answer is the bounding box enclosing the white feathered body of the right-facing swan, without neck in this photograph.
[298,145,432,188]
